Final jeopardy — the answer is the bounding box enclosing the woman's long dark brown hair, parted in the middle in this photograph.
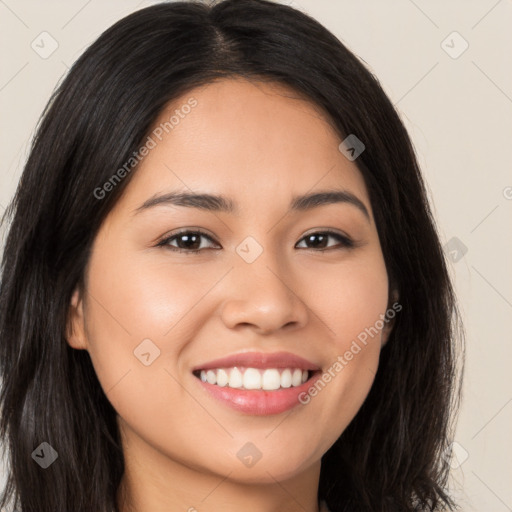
[0,0,463,512]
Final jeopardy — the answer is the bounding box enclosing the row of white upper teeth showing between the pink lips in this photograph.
[199,367,309,391]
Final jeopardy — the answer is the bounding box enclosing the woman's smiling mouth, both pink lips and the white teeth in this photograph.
[192,352,322,415]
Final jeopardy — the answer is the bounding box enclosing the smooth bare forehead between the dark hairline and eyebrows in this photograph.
[114,79,370,217]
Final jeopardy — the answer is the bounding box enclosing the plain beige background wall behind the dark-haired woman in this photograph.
[0,0,512,512]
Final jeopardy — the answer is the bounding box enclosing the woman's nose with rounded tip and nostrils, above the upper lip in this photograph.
[221,250,309,334]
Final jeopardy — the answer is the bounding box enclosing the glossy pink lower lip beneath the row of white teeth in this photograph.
[194,372,321,416]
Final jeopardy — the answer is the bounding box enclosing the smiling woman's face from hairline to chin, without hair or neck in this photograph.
[69,80,388,482]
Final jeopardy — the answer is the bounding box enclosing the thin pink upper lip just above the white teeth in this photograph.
[192,352,320,371]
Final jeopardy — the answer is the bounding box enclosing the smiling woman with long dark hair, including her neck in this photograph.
[0,0,460,512]
